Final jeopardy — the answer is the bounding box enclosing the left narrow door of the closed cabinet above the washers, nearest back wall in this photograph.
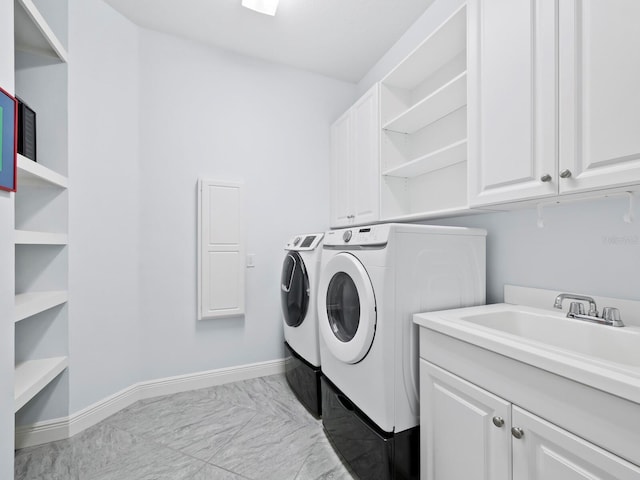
[329,111,353,227]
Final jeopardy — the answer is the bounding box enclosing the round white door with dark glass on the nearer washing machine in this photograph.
[318,253,376,363]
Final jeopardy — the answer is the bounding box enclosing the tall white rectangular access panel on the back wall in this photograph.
[198,179,245,320]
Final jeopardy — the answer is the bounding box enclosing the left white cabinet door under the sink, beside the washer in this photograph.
[420,360,511,480]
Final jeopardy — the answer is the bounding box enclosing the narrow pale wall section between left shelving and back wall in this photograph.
[69,0,143,413]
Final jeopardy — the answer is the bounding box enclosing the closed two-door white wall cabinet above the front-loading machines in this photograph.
[330,84,380,228]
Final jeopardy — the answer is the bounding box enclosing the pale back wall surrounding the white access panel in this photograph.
[140,31,355,379]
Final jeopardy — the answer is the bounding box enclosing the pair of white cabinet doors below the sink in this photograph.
[420,359,640,480]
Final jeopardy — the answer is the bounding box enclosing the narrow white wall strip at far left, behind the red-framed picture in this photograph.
[0,2,15,472]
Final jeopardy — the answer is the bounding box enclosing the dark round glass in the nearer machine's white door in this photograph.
[327,272,360,342]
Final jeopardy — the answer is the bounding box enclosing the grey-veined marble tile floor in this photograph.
[15,375,354,480]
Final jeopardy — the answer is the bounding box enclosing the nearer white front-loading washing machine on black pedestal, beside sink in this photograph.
[318,224,486,480]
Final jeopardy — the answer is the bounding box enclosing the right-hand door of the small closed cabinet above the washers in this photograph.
[351,84,380,224]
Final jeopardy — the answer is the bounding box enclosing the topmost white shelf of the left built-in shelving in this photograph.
[14,0,67,63]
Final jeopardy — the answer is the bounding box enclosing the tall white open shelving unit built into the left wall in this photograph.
[13,0,69,416]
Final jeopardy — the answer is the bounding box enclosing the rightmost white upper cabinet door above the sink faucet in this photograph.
[559,0,640,193]
